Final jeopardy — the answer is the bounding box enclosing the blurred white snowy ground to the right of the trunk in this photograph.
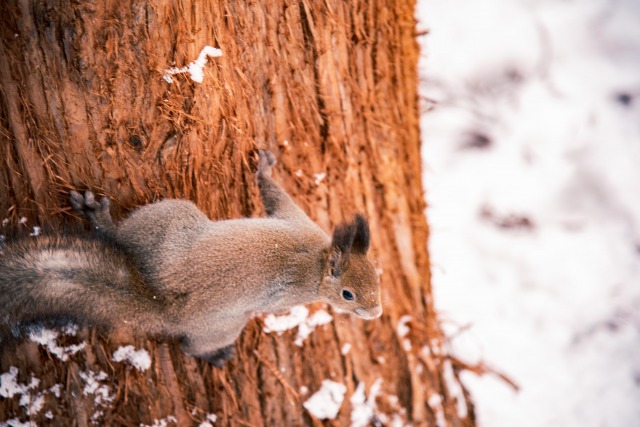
[418,0,640,427]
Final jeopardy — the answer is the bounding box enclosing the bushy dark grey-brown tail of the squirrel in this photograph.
[0,236,164,334]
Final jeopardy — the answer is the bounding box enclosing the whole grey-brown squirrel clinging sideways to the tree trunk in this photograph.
[0,150,382,366]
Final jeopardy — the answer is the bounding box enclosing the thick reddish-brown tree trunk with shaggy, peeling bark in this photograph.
[0,0,474,426]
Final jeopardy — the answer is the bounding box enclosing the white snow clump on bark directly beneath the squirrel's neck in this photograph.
[263,305,333,347]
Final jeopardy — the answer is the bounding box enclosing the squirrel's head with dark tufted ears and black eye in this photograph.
[320,215,382,319]
